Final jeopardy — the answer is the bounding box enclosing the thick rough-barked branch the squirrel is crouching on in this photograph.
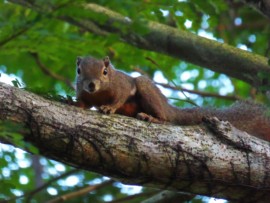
[0,83,270,202]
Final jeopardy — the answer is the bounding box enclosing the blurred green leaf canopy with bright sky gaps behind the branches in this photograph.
[0,0,270,202]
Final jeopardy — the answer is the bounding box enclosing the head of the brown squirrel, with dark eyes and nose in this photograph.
[76,56,113,94]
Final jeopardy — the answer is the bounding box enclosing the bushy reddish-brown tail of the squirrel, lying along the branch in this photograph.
[171,101,270,141]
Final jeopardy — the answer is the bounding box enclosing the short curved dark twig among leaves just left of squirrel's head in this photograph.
[30,52,75,90]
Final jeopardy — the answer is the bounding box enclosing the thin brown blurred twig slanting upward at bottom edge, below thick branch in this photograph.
[47,180,114,203]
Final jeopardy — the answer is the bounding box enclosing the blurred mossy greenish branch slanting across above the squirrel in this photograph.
[7,0,270,86]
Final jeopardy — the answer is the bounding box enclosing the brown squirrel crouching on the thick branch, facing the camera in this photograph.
[76,57,270,141]
